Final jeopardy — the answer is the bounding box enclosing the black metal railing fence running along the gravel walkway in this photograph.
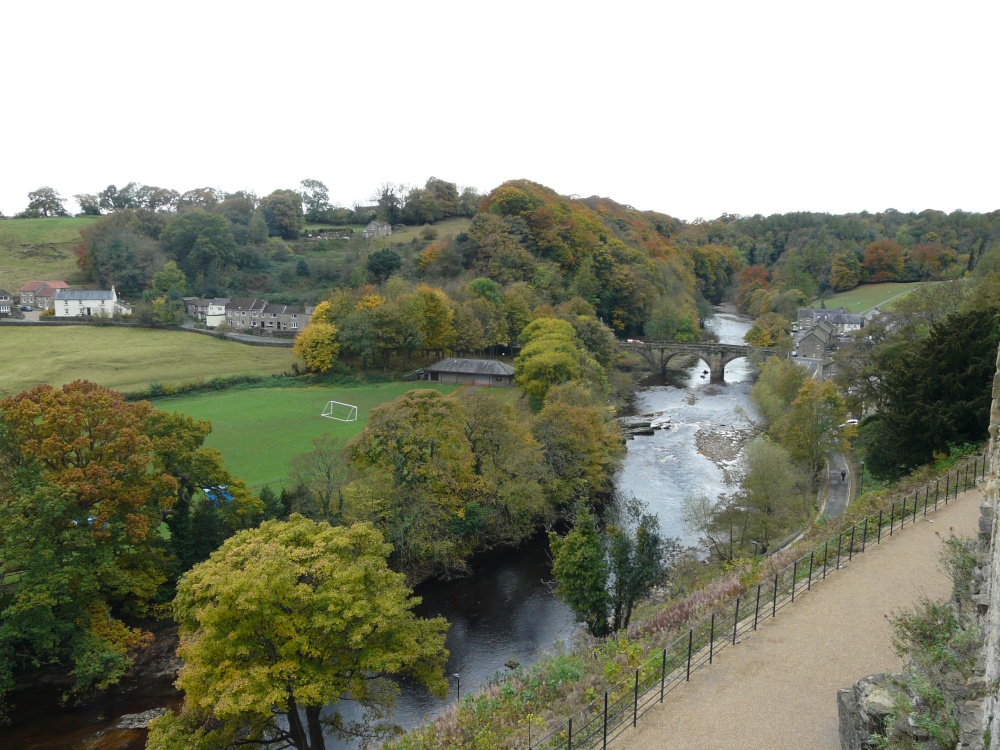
[527,456,987,750]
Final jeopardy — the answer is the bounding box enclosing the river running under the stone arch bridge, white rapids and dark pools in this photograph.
[0,313,753,750]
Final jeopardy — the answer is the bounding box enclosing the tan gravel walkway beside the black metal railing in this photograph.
[614,490,982,750]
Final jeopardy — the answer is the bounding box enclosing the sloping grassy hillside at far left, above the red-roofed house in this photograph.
[0,216,95,293]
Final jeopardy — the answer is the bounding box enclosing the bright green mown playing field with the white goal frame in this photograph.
[153,383,458,489]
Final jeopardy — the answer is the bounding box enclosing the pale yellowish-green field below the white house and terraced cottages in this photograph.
[0,326,298,396]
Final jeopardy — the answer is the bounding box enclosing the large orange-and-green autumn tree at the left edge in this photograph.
[0,381,187,704]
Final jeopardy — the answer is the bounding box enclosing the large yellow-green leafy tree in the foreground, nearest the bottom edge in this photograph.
[147,515,448,750]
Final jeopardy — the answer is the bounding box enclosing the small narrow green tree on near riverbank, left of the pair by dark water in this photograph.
[549,504,609,637]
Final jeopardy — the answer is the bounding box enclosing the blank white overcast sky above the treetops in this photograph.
[0,0,1000,220]
